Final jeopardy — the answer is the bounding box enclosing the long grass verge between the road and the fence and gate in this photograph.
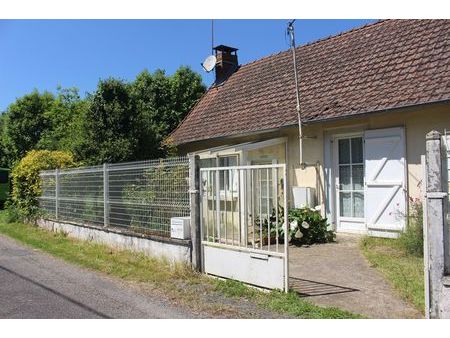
[0,212,360,318]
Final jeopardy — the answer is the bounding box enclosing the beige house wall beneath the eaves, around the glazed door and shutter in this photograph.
[180,104,450,211]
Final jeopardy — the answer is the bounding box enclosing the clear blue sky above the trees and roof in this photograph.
[0,20,374,112]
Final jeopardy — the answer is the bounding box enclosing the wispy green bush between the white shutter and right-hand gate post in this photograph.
[398,197,423,256]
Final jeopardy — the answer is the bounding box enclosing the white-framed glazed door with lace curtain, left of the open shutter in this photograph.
[334,134,366,233]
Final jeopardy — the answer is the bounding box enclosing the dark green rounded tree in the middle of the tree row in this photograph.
[74,78,140,165]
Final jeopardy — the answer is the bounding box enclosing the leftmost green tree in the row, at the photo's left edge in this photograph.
[2,90,55,166]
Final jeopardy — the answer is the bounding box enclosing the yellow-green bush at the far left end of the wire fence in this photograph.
[9,150,75,221]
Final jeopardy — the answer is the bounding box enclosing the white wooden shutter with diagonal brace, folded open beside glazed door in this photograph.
[364,128,406,237]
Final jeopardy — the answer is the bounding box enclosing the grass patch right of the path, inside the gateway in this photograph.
[361,237,425,313]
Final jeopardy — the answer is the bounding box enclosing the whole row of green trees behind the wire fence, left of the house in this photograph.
[0,67,205,167]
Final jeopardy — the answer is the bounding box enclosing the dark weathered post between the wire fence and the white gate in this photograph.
[189,155,202,271]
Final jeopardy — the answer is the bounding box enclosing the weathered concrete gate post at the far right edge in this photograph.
[424,131,450,318]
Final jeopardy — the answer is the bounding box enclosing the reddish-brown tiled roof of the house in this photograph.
[172,20,450,144]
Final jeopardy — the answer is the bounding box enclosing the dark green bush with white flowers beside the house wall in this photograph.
[264,207,336,245]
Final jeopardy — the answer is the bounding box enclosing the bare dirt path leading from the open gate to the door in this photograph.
[289,235,422,318]
